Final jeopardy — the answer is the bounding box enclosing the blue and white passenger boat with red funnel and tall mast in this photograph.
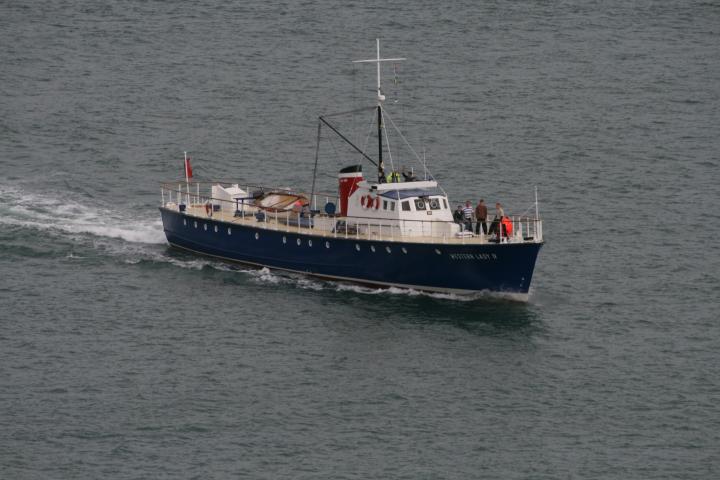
[160,39,544,300]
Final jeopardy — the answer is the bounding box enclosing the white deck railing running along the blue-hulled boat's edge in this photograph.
[160,182,543,243]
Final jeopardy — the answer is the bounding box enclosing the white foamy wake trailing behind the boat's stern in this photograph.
[0,185,165,244]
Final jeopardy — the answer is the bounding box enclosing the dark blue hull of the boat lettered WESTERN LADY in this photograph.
[160,208,542,294]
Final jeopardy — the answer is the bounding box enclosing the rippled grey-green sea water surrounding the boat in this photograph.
[0,0,720,479]
